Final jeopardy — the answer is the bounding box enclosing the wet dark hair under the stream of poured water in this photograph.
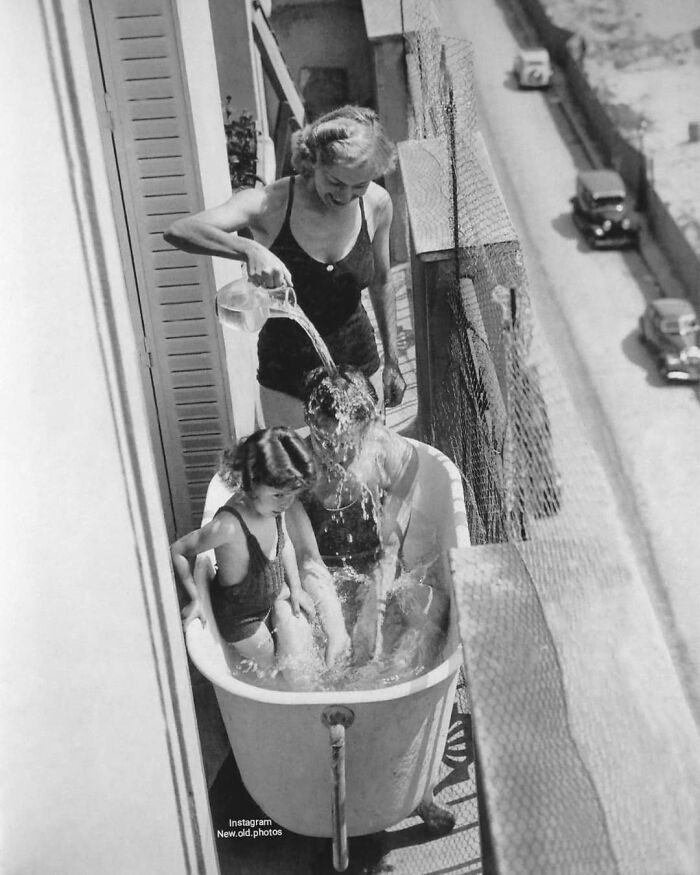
[304,368,378,425]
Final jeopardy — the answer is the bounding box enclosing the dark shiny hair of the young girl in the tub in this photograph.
[219,426,316,492]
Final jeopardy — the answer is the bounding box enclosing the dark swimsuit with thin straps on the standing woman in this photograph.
[258,176,379,399]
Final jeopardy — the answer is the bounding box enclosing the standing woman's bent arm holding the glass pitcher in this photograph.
[163,188,292,288]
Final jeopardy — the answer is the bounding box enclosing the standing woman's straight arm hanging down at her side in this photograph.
[369,186,406,407]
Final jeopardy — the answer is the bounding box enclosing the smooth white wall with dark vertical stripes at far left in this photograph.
[0,0,217,875]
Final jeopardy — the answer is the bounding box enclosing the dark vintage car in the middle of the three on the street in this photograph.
[571,170,639,248]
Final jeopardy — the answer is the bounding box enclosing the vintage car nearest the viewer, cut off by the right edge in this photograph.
[639,298,700,383]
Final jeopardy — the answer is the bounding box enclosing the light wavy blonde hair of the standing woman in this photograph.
[292,105,396,179]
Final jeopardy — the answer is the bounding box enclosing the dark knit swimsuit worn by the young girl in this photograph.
[211,504,284,643]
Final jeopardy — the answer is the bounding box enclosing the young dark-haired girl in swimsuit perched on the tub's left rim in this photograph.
[170,427,330,686]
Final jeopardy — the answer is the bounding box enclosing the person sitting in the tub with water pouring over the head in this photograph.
[290,368,418,663]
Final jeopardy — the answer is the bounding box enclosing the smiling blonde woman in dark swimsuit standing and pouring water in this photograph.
[165,106,405,428]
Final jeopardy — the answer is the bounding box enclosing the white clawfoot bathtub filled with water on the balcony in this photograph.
[186,442,469,837]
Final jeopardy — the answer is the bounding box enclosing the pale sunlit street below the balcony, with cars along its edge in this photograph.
[441,0,700,723]
